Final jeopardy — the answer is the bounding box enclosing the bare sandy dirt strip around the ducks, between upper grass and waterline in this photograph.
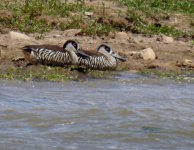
[0,29,194,71]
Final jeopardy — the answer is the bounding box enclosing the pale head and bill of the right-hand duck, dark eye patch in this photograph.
[97,44,126,62]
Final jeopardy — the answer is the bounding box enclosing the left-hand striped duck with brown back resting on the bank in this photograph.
[21,40,85,66]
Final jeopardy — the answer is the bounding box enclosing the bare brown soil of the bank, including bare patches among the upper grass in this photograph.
[0,0,194,73]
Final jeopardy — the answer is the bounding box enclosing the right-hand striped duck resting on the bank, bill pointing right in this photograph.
[77,44,126,70]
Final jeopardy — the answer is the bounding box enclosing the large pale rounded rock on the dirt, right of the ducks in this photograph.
[140,48,156,60]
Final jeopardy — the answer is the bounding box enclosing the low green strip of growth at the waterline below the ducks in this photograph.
[0,65,118,82]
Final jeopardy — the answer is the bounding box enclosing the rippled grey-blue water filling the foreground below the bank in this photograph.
[0,73,194,150]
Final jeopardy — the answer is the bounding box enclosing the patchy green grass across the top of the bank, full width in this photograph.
[0,0,194,37]
